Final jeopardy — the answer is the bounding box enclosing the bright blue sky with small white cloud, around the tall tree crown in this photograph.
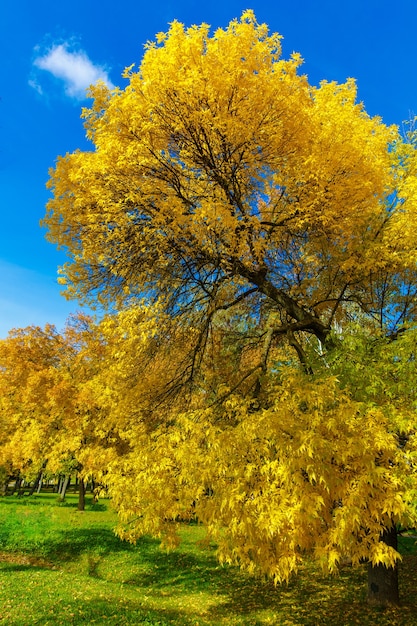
[0,0,417,338]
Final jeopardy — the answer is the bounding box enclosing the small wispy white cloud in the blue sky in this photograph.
[29,43,114,100]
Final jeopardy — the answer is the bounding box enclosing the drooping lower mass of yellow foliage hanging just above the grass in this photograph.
[101,372,417,582]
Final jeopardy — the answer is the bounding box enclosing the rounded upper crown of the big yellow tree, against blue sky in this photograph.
[43,12,416,340]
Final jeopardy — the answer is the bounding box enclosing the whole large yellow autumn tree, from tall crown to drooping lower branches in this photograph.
[44,11,417,601]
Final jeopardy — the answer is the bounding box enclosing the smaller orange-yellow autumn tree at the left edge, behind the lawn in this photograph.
[0,314,111,508]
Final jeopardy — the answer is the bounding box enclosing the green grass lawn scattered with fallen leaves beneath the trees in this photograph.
[0,494,417,626]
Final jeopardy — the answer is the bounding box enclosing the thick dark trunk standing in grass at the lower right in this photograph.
[368,525,400,606]
